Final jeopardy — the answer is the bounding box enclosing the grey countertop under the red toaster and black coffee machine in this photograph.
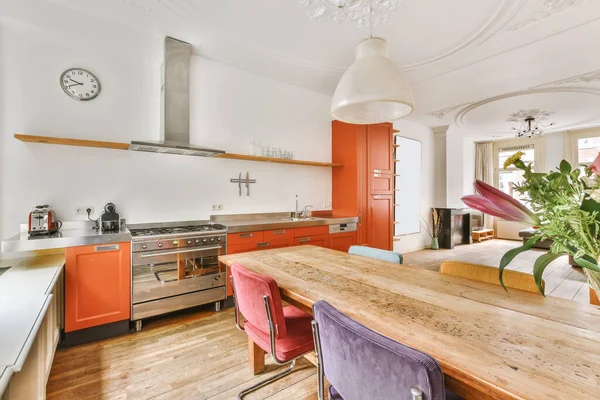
[0,228,131,253]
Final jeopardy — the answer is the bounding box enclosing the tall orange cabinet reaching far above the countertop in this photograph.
[331,121,394,250]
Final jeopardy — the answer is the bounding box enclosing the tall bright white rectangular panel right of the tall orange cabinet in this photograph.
[394,136,421,236]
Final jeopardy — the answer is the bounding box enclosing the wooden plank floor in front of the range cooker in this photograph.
[47,308,324,400]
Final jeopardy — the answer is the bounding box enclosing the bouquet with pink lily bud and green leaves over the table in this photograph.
[462,152,600,294]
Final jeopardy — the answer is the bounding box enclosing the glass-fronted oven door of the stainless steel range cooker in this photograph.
[132,245,226,304]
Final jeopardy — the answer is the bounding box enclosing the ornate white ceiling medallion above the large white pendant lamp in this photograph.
[298,0,402,28]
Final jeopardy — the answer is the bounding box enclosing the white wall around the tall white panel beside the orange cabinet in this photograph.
[394,120,436,253]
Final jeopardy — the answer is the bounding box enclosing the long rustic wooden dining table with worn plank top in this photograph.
[219,246,600,400]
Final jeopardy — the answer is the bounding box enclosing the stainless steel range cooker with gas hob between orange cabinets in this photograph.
[128,221,227,330]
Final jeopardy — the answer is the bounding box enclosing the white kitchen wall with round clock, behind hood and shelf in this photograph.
[0,6,331,238]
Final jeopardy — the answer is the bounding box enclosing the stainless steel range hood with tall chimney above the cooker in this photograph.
[129,37,225,157]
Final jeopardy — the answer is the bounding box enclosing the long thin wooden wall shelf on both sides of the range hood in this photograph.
[15,133,342,167]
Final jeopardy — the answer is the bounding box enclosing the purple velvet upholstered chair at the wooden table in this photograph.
[313,301,460,400]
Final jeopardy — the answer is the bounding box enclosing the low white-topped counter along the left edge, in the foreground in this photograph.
[0,254,65,397]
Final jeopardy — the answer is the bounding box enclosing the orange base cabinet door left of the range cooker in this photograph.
[65,242,131,332]
